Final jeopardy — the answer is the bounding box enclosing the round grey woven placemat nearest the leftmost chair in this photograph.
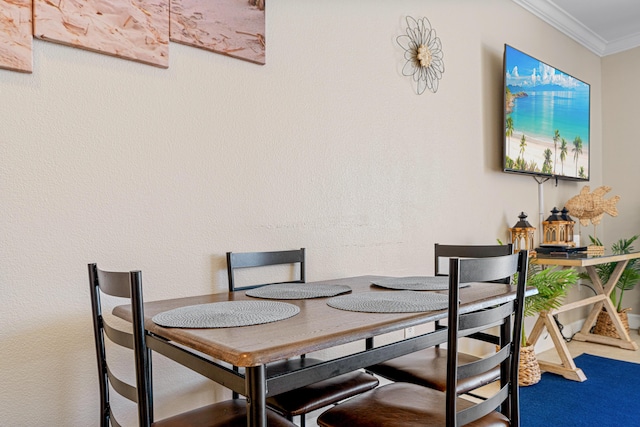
[152,301,300,328]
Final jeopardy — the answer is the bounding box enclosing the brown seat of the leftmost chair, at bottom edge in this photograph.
[151,399,295,427]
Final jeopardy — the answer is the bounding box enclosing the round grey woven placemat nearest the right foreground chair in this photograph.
[327,291,449,313]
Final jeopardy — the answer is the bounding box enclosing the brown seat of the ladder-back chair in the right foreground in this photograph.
[318,383,509,427]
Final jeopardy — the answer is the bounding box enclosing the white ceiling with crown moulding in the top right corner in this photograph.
[513,0,640,56]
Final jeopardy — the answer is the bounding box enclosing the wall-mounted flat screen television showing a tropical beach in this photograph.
[503,44,591,181]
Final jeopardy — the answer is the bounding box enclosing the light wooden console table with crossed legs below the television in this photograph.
[527,251,640,382]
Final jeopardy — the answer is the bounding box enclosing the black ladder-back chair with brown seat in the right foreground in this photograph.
[318,251,528,427]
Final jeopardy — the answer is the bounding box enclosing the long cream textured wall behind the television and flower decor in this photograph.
[0,0,604,426]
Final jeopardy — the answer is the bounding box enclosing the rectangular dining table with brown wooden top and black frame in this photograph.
[113,275,535,427]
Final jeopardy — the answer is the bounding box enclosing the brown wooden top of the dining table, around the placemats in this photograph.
[113,276,515,367]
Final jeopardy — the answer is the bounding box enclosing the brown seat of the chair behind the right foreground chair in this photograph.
[367,347,500,393]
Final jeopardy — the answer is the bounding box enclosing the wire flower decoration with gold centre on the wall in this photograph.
[396,16,444,95]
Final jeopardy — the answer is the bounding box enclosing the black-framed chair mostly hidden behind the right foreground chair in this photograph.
[367,243,513,392]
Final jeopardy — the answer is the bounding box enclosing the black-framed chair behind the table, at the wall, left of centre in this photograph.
[227,248,379,427]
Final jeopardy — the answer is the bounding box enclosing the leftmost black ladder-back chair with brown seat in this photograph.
[89,264,295,427]
